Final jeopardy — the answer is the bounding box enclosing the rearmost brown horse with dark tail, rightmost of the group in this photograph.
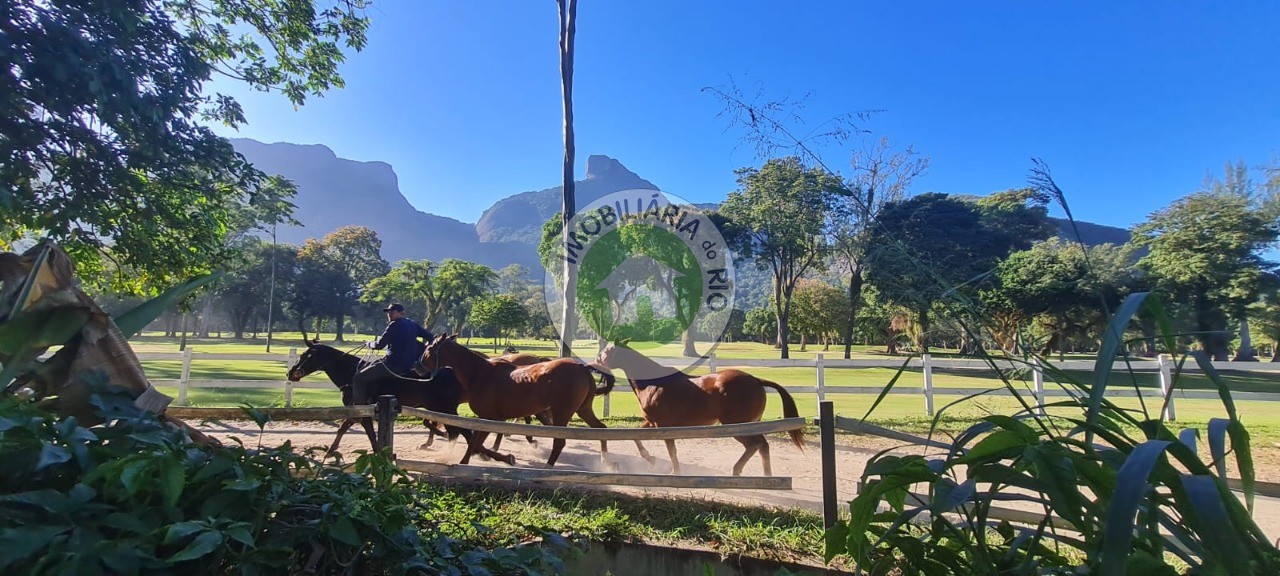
[596,344,804,476]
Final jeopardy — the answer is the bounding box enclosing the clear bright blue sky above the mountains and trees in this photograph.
[204,0,1280,227]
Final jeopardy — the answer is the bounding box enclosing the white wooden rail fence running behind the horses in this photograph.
[149,347,1280,420]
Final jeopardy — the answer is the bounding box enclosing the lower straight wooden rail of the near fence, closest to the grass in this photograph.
[396,460,791,490]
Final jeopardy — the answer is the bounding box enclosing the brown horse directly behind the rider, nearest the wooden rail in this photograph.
[422,334,613,468]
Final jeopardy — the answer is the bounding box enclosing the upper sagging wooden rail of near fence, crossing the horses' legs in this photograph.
[401,406,805,440]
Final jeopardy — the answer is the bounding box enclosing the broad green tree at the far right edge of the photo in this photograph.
[1134,179,1280,361]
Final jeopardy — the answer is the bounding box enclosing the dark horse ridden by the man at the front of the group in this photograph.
[288,340,515,465]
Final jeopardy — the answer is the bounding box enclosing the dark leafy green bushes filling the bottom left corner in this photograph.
[0,394,573,575]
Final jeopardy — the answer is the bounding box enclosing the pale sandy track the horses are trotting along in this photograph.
[189,422,1280,539]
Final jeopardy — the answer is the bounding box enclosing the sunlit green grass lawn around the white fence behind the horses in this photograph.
[133,333,1280,443]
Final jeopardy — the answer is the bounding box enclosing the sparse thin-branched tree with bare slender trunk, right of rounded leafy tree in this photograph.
[831,138,929,358]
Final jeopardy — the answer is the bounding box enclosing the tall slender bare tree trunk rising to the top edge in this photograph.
[556,0,577,357]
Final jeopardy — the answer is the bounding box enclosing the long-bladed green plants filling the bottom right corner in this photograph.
[827,293,1280,575]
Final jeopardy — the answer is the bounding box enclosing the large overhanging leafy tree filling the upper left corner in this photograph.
[0,0,367,291]
